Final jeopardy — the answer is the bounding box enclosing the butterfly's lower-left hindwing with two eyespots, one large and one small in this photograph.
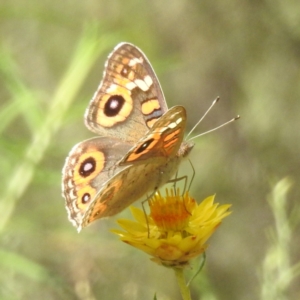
[62,137,132,227]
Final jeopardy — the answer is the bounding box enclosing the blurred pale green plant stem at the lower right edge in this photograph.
[261,178,300,300]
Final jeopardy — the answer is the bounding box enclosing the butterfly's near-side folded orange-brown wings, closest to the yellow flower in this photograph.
[79,106,186,230]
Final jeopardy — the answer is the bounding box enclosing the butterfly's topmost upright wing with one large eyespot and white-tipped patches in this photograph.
[85,43,168,142]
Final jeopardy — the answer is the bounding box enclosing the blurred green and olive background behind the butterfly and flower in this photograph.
[0,0,300,300]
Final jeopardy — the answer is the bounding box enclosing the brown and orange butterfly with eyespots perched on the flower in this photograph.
[62,43,194,231]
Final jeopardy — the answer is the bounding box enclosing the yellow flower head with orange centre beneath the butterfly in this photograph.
[113,189,231,267]
